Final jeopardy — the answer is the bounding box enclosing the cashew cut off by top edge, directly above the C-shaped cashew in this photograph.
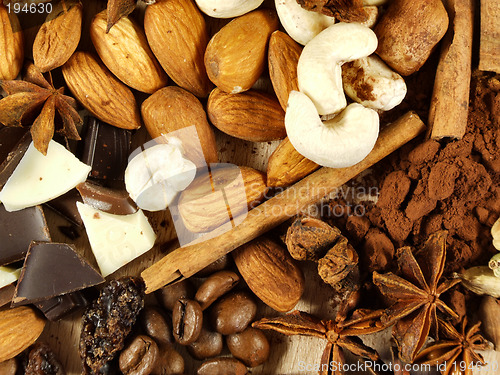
[274,0,335,45]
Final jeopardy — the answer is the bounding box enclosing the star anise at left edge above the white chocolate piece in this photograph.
[0,64,83,155]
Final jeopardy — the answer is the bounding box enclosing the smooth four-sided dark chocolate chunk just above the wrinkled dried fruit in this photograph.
[12,242,104,306]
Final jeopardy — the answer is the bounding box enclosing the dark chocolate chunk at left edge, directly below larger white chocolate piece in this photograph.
[0,205,50,266]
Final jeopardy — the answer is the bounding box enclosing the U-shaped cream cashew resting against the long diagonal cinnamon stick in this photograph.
[285,91,379,168]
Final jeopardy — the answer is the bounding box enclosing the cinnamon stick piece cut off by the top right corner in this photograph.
[479,0,500,73]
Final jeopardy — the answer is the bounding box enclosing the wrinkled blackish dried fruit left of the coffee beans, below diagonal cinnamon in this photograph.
[80,277,145,375]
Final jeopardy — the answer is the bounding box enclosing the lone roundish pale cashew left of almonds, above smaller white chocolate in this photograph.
[125,137,196,211]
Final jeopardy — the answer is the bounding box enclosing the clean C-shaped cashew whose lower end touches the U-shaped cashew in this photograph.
[297,22,377,115]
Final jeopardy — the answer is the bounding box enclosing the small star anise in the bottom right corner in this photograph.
[415,317,488,375]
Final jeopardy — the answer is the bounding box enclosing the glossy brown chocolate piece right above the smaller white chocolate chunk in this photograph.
[76,182,137,215]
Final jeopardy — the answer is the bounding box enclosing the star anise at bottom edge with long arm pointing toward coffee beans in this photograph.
[252,309,384,375]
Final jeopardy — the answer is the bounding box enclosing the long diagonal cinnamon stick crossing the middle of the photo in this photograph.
[141,112,425,293]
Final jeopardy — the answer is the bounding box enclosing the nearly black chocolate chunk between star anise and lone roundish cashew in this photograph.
[81,117,131,185]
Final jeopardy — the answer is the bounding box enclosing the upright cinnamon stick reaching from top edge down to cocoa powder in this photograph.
[429,0,474,139]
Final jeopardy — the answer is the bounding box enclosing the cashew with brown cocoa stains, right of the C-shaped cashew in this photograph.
[342,55,406,111]
